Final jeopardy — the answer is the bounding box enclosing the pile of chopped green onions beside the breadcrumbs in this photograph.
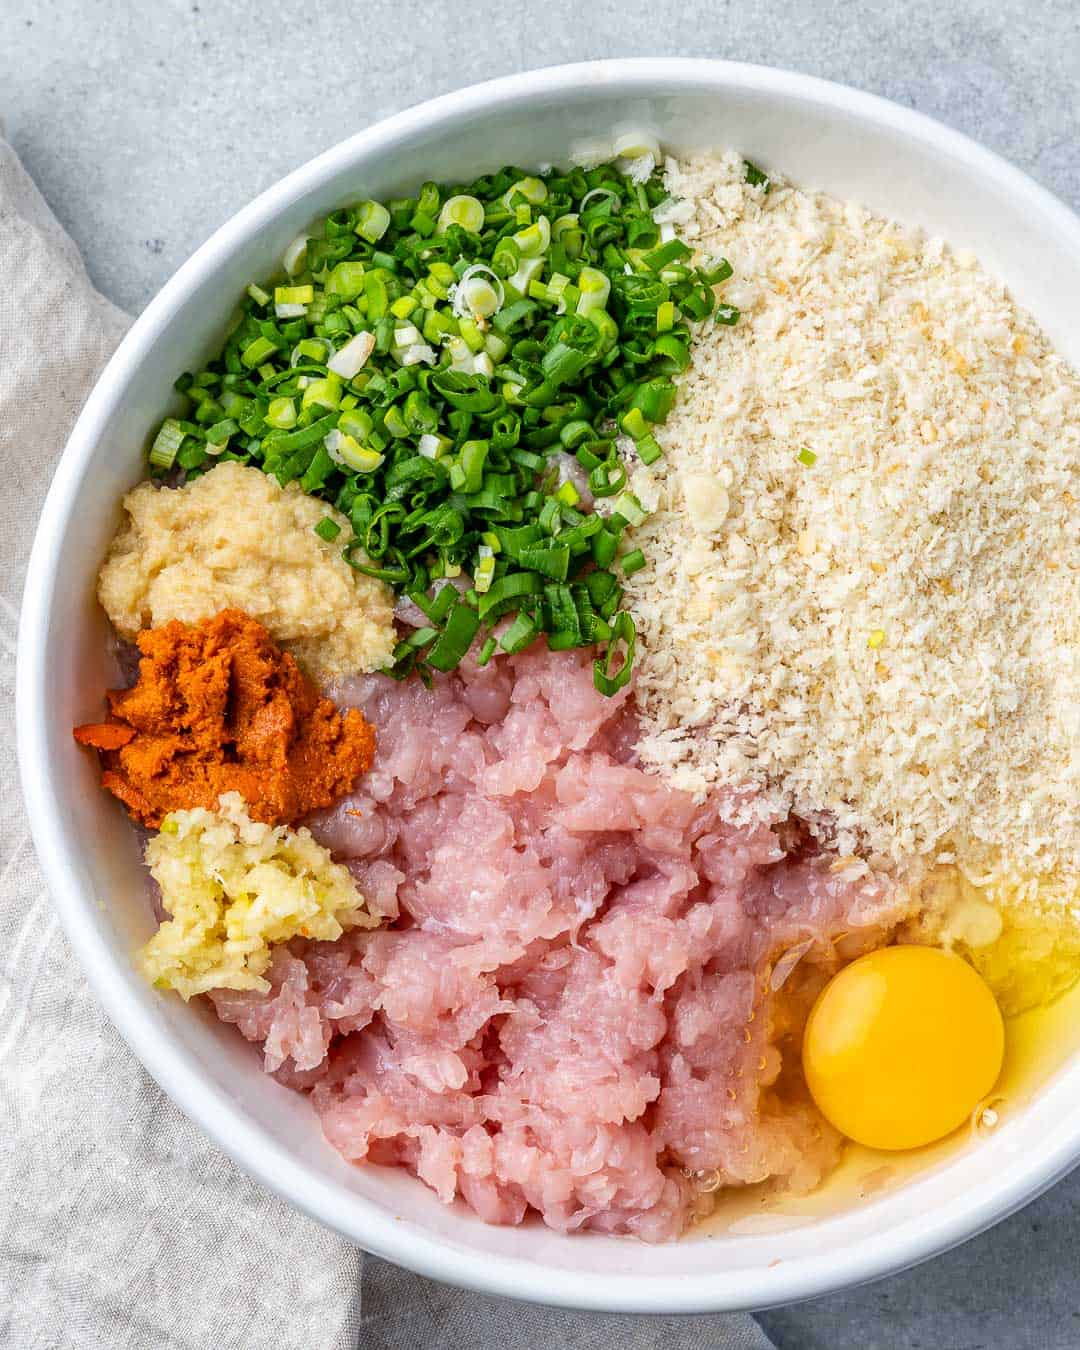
[151,153,738,690]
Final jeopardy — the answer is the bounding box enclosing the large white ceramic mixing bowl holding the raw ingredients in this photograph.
[18,59,1080,1314]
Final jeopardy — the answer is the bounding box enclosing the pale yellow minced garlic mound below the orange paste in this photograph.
[139,792,379,999]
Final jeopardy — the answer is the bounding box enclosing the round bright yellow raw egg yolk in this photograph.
[802,946,1004,1149]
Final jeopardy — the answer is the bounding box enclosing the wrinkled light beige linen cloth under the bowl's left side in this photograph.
[0,140,771,1350]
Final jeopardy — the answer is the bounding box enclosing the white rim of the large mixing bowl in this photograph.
[16,57,1080,1315]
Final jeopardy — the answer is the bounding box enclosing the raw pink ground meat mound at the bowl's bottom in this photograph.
[212,648,899,1241]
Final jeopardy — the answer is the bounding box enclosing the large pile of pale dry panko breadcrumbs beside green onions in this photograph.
[628,155,1080,903]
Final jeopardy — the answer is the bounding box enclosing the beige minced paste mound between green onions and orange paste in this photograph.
[97,460,394,679]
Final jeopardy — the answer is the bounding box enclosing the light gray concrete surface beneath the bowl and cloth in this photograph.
[0,0,1080,1350]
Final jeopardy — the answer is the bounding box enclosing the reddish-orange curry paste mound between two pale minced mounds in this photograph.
[74,609,375,828]
